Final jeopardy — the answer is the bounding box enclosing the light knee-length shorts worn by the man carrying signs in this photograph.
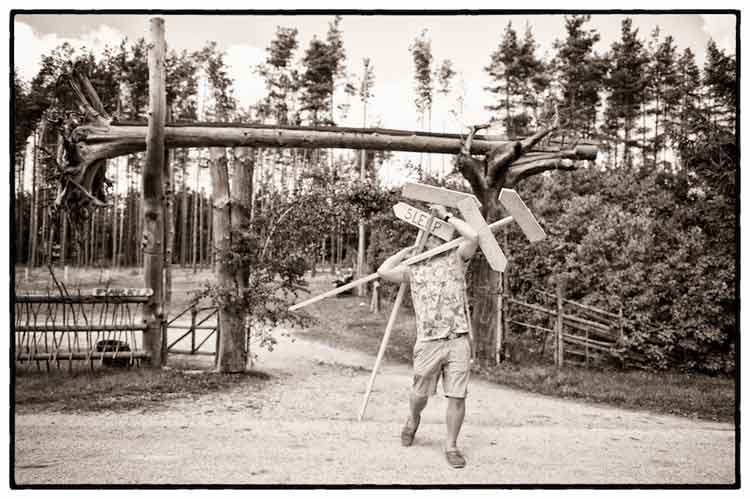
[412,334,471,398]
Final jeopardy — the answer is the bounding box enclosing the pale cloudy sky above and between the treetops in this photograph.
[14,14,735,186]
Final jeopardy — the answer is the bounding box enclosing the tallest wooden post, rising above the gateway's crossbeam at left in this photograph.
[142,17,166,367]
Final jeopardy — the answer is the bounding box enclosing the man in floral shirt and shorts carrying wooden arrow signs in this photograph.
[378,205,477,468]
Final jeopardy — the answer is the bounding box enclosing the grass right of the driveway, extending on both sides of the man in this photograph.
[302,272,735,422]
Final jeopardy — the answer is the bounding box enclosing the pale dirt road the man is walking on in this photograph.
[15,332,735,486]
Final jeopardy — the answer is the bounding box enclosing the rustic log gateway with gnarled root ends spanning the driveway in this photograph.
[32,18,597,371]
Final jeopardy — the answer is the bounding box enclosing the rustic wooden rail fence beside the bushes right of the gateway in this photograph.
[502,289,623,367]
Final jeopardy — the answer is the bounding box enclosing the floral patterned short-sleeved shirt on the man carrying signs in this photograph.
[409,250,469,342]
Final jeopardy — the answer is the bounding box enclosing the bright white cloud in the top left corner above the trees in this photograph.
[13,21,125,81]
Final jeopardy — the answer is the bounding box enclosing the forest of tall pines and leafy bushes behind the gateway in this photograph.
[11,15,739,373]
